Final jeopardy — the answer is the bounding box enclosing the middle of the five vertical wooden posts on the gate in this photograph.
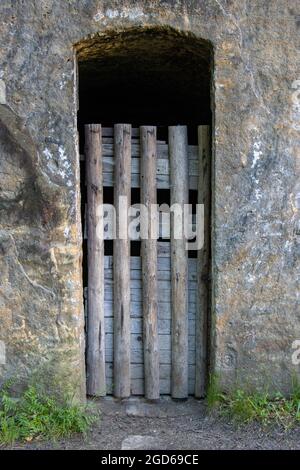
[140,126,159,400]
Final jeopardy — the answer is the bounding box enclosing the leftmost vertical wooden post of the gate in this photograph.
[85,124,106,396]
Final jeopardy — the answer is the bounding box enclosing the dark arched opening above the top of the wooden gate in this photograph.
[78,28,211,145]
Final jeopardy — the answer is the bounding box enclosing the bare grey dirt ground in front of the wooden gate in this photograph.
[2,398,300,450]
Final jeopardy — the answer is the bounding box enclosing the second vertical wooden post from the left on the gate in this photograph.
[113,124,131,398]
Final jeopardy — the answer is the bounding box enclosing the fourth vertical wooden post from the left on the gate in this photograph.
[169,126,188,398]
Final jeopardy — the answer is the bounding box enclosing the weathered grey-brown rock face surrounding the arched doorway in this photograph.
[0,0,300,398]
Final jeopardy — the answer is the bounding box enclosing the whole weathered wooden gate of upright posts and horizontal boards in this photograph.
[83,124,210,400]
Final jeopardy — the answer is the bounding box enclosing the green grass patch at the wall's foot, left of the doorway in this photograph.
[0,386,96,444]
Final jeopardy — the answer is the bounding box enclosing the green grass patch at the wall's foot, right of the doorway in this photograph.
[207,376,300,429]
